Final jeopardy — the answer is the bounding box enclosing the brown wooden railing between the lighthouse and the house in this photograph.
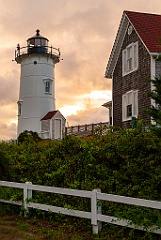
[65,122,109,136]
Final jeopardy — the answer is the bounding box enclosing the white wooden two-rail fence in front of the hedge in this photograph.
[0,181,161,234]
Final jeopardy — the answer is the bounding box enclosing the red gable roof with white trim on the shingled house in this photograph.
[105,11,161,78]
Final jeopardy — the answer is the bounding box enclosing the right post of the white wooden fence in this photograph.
[91,189,102,234]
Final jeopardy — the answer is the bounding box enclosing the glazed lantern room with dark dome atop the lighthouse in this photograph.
[27,29,49,53]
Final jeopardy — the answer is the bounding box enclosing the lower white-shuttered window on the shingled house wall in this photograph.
[122,90,138,121]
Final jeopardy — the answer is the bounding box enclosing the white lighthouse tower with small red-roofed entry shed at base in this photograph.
[15,29,65,138]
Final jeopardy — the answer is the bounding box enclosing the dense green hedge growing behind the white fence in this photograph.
[0,127,161,239]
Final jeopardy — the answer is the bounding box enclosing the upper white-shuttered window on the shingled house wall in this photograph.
[122,42,138,76]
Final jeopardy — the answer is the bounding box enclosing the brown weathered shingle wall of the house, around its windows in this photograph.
[113,25,151,128]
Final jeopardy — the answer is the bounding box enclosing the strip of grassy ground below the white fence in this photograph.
[0,208,161,240]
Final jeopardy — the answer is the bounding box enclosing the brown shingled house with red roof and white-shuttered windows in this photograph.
[103,11,161,128]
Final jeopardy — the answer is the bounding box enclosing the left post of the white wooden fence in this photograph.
[23,182,32,217]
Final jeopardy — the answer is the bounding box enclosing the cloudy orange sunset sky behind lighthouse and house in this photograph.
[0,0,161,140]
